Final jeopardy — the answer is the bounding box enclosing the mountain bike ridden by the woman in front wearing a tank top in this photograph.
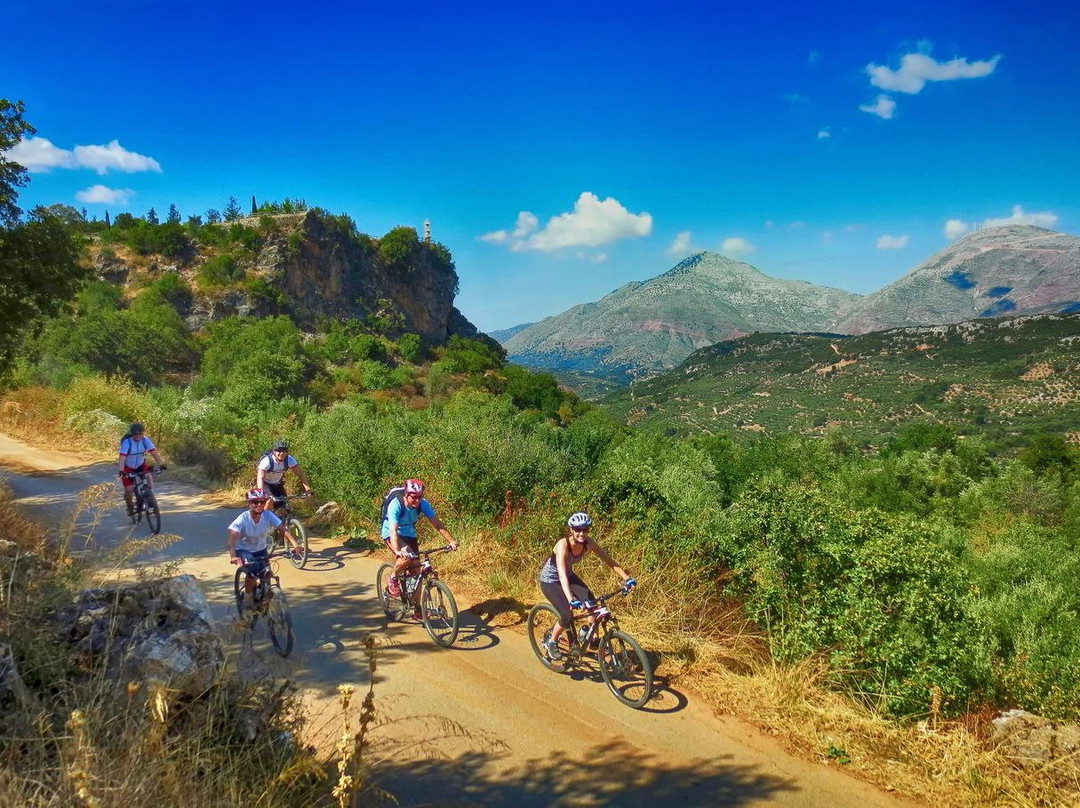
[526,588,652,708]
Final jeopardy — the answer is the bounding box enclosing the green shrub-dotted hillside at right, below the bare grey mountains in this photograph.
[605,314,1080,445]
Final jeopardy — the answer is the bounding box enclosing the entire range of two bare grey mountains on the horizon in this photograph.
[500,225,1080,383]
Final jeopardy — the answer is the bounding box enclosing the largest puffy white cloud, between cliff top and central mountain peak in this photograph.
[480,191,652,253]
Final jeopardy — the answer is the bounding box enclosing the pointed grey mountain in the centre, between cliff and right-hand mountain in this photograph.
[504,253,860,383]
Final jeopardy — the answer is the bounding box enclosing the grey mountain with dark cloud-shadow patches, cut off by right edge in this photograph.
[829,225,1080,334]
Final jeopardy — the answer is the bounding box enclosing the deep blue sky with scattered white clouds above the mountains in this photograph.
[0,0,1080,331]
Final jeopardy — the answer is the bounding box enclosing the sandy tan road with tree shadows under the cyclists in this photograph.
[0,435,910,808]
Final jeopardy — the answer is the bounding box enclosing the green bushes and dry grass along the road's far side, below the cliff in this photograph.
[0,97,1080,806]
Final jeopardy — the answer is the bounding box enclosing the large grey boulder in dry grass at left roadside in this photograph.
[59,575,225,696]
